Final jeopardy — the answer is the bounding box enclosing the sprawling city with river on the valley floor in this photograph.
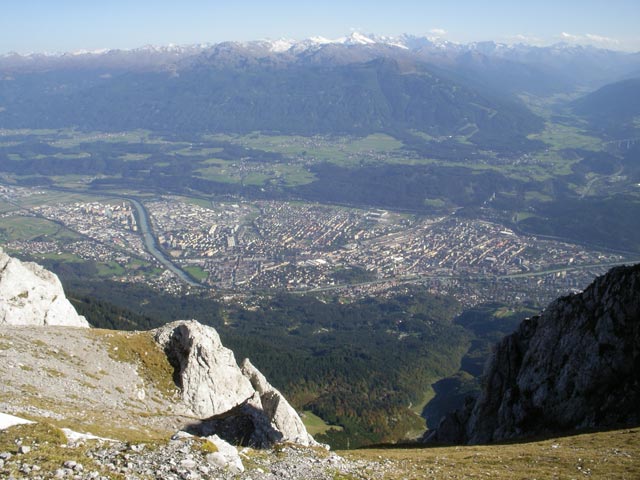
[0,186,633,305]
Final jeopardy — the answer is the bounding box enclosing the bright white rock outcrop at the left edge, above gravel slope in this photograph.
[0,248,89,328]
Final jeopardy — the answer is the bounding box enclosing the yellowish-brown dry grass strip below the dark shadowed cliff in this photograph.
[340,429,640,480]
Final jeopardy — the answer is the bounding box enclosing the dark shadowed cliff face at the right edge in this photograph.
[425,265,640,444]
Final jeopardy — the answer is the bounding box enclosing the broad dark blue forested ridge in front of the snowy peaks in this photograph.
[0,49,542,144]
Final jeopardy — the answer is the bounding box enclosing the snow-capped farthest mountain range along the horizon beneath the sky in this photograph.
[0,32,640,89]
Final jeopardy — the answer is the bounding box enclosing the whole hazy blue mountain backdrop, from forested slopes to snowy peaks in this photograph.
[0,33,640,145]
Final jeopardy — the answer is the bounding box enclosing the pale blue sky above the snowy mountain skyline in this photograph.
[0,0,640,54]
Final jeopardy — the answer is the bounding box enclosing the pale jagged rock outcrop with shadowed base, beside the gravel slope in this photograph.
[154,320,317,447]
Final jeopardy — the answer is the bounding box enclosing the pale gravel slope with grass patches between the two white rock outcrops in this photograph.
[0,327,193,436]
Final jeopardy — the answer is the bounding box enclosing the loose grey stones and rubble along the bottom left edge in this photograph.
[0,431,382,480]
